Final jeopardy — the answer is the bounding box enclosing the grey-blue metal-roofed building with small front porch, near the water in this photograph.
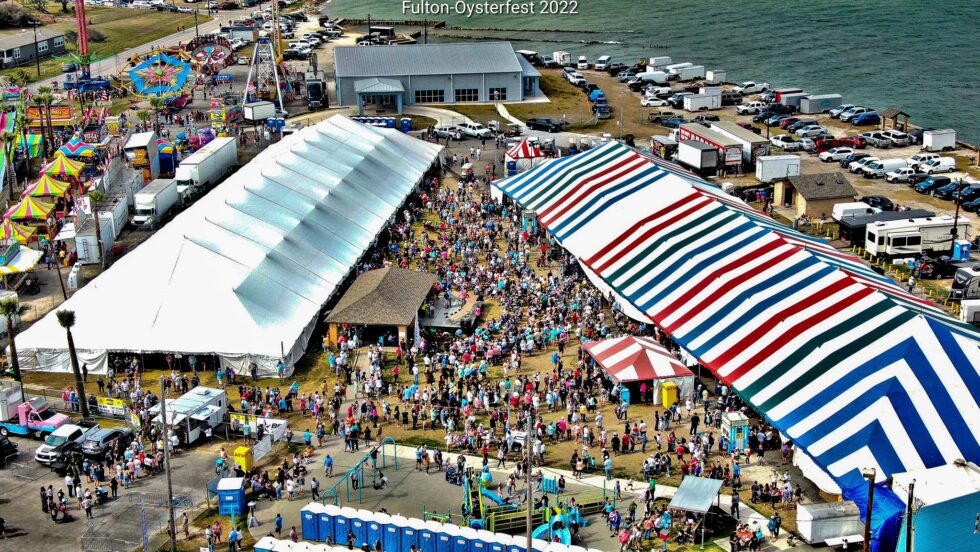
[334,42,541,115]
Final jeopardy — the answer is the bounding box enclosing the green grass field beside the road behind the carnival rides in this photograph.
[0,4,211,82]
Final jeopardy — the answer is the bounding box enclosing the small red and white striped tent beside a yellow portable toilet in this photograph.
[584,336,694,404]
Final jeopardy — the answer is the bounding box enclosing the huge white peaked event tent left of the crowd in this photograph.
[17,116,440,374]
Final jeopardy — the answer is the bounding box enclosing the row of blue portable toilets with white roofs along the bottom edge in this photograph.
[290,502,598,552]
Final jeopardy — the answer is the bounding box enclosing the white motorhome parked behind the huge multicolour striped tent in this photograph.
[864,215,971,259]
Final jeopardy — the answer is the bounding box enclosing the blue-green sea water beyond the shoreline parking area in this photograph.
[326,0,980,143]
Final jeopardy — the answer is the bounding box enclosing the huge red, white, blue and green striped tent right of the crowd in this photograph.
[495,142,980,495]
